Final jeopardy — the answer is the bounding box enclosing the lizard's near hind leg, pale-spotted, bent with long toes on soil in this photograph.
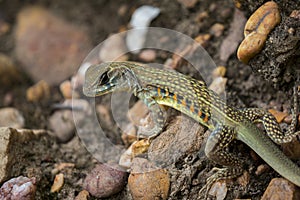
[199,125,243,198]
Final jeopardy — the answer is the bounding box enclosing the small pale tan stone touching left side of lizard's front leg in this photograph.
[128,100,149,125]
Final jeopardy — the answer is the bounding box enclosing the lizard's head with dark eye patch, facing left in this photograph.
[83,62,137,97]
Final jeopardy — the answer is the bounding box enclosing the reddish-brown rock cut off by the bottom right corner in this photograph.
[261,178,300,200]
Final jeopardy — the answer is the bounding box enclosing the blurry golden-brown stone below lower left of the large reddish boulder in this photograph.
[26,80,50,102]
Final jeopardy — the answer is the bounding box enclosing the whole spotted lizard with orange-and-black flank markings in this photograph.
[83,62,300,197]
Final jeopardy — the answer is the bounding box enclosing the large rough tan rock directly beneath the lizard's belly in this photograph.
[148,115,205,166]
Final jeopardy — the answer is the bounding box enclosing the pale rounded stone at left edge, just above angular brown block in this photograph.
[0,107,25,128]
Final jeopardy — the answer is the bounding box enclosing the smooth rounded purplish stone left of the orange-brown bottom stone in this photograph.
[83,164,127,198]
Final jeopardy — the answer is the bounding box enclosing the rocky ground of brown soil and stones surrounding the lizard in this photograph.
[0,0,300,200]
